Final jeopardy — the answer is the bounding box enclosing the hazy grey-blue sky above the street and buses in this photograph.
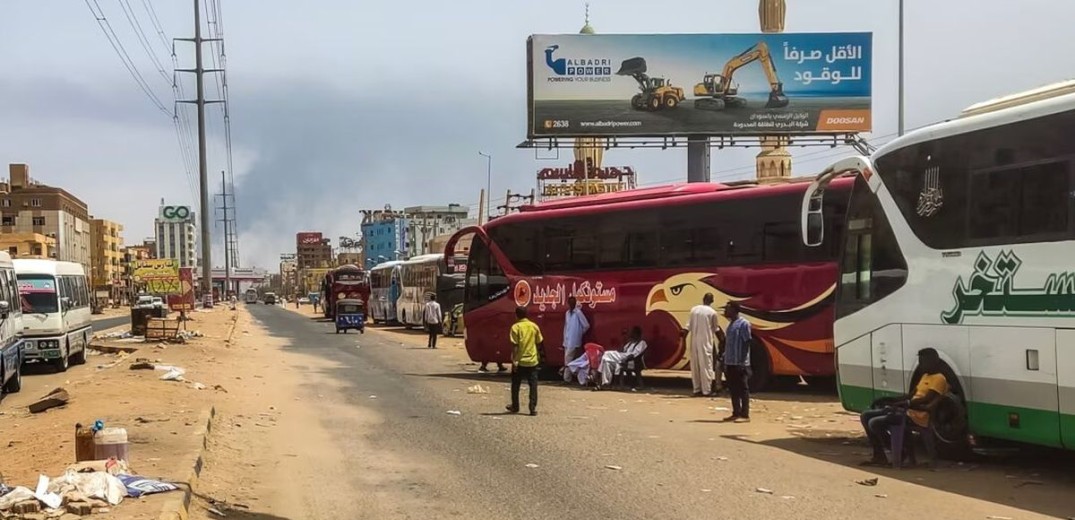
[0,0,1075,268]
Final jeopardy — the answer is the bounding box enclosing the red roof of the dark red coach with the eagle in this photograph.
[486,177,845,227]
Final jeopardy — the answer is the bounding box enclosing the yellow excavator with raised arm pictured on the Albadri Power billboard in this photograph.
[694,42,788,111]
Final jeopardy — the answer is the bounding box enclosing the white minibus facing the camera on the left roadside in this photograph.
[14,259,94,372]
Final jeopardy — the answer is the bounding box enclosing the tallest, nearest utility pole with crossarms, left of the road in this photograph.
[176,0,224,301]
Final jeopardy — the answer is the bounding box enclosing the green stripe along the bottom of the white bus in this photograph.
[840,385,1075,448]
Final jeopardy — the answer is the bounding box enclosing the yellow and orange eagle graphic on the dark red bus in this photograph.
[646,273,836,370]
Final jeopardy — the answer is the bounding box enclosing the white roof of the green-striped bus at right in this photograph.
[873,81,1075,157]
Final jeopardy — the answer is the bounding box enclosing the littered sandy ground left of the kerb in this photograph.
[0,307,242,519]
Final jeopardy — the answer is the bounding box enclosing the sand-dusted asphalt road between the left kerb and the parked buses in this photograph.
[196,305,1075,520]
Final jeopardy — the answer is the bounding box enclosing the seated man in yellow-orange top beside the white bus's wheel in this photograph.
[860,348,948,465]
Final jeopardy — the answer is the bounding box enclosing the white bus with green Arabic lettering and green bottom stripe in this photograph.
[802,82,1075,449]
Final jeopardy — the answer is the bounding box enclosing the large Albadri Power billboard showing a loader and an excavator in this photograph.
[527,32,873,139]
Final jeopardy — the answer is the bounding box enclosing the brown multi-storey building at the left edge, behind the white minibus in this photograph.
[0,164,90,273]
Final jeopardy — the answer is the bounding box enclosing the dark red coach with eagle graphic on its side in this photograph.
[445,178,847,389]
